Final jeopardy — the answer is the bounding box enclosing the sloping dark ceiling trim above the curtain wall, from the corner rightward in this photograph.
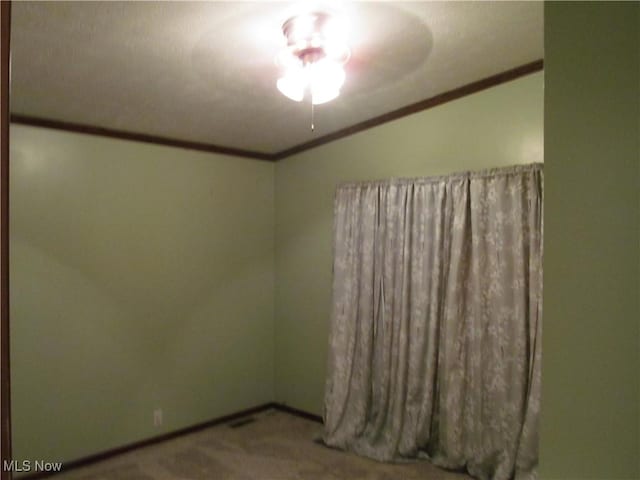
[275,60,544,160]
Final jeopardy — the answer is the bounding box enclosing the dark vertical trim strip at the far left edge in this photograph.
[0,1,11,480]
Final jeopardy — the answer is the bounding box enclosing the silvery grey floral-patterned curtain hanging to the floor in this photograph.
[324,164,543,480]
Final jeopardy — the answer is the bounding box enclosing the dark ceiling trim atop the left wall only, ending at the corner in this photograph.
[11,113,274,161]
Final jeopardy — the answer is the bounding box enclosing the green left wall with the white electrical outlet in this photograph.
[10,125,274,461]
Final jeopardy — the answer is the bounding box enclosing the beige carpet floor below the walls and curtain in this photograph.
[54,410,471,480]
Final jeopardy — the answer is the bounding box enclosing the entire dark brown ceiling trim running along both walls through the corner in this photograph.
[11,60,544,161]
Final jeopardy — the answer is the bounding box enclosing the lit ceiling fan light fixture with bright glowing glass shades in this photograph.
[276,12,351,105]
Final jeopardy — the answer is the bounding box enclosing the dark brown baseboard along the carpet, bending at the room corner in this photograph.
[16,402,322,480]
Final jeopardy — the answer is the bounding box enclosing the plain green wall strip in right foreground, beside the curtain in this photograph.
[541,2,640,479]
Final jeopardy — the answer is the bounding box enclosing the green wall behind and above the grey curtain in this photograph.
[275,73,544,414]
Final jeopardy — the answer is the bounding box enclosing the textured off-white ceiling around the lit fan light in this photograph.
[11,2,543,157]
